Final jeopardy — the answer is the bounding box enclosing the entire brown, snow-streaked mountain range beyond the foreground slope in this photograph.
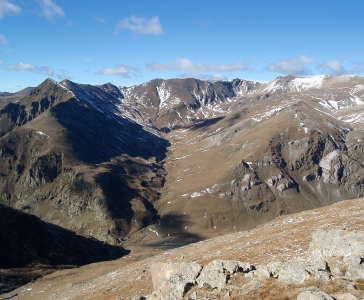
[0,75,364,246]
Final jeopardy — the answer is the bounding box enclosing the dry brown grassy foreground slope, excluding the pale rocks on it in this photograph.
[4,199,364,299]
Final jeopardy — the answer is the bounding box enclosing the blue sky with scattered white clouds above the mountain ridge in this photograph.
[0,0,364,92]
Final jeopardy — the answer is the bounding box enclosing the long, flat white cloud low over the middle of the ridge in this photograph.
[147,58,248,72]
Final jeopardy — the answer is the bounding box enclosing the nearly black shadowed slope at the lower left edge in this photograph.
[0,205,127,269]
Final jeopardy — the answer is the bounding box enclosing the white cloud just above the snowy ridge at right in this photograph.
[266,55,315,75]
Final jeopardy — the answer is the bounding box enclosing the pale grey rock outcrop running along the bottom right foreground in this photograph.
[147,229,364,300]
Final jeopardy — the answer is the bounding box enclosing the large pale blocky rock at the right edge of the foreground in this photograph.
[308,229,364,279]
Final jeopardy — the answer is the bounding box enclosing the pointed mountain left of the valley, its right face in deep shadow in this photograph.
[0,80,168,243]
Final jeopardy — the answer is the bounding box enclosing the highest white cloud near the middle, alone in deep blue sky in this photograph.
[115,16,163,35]
